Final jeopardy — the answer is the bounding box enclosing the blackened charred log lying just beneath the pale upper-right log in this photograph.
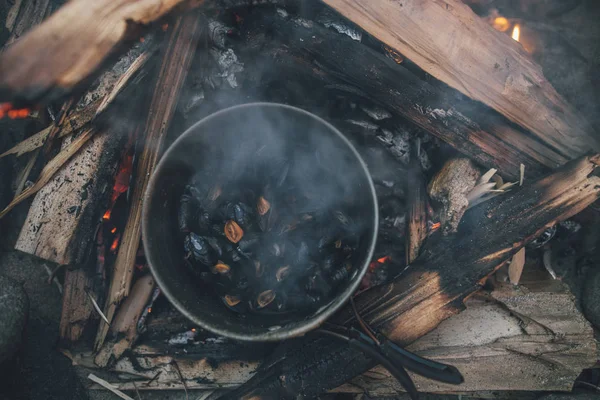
[241,10,568,180]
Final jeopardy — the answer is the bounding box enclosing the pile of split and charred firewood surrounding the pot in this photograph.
[0,0,600,399]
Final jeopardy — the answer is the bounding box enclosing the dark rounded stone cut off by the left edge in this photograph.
[0,275,29,362]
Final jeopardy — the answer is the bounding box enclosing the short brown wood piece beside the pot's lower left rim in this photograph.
[94,275,155,367]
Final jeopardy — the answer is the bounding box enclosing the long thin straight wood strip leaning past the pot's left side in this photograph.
[95,12,203,349]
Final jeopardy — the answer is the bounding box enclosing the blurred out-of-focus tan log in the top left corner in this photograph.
[0,0,204,103]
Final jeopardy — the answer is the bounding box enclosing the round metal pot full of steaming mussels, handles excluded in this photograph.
[143,103,378,341]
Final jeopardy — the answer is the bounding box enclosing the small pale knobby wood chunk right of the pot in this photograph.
[427,158,481,235]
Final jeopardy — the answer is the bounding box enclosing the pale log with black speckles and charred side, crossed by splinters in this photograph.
[15,50,151,264]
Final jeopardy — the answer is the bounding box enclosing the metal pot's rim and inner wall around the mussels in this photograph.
[142,103,379,341]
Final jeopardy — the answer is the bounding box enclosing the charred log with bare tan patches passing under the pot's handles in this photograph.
[222,155,600,399]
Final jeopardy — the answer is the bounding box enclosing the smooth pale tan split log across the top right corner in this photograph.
[324,0,600,159]
